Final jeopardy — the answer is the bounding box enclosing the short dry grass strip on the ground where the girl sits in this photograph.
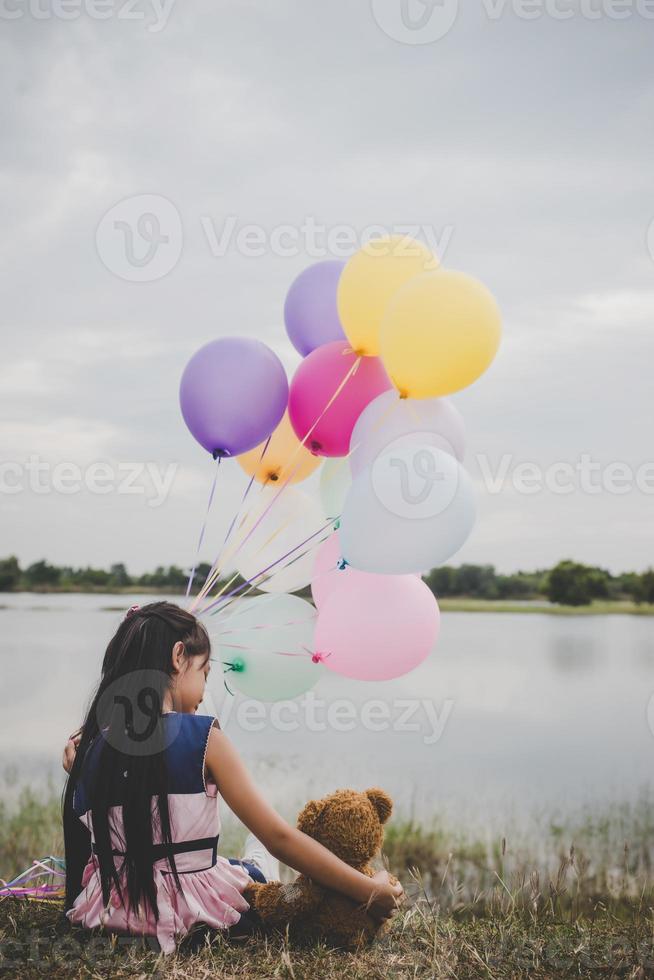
[0,898,654,980]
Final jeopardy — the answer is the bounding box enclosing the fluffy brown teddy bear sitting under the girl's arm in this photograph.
[244,789,395,949]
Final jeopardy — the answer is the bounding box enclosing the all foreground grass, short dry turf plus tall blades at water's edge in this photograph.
[0,790,654,980]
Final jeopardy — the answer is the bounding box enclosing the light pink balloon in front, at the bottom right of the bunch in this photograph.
[314,575,440,681]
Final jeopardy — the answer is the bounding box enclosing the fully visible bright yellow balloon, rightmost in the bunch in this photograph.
[381,269,502,398]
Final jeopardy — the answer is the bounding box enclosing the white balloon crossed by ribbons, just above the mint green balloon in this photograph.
[230,486,329,592]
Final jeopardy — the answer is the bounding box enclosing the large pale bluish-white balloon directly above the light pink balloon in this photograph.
[339,437,475,575]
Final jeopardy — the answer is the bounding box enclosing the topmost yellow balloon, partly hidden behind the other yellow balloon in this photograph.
[337,235,439,357]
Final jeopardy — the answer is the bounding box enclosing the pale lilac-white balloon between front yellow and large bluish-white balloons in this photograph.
[349,391,466,476]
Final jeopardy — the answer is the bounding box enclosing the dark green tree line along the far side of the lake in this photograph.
[0,555,654,606]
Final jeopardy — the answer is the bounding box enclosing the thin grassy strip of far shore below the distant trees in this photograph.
[0,586,654,616]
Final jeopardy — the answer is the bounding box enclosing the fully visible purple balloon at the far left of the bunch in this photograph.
[179,337,288,457]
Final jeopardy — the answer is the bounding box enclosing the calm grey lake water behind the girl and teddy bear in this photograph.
[0,594,654,827]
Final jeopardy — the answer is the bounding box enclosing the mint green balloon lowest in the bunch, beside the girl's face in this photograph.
[216,593,325,701]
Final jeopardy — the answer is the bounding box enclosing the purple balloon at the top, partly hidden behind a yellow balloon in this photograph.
[284,259,346,357]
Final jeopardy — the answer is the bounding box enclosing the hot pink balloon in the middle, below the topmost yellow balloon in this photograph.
[288,340,391,456]
